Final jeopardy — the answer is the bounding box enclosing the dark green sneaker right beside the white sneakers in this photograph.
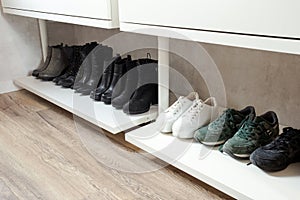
[194,106,255,146]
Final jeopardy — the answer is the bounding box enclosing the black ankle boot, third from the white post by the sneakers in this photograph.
[101,55,131,104]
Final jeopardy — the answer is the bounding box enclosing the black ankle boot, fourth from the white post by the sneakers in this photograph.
[90,55,121,101]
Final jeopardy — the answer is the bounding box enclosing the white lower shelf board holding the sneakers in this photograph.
[125,123,300,200]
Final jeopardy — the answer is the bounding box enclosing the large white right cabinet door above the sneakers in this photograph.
[119,0,300,38]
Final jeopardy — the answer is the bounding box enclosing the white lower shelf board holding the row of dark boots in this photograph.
[15,76,157,134]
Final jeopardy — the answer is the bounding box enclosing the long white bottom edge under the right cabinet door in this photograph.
[120,22,300,55]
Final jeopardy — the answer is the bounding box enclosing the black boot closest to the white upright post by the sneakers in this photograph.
[123,58,158,114]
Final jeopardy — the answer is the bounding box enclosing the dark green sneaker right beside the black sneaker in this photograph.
[223,111,279,158]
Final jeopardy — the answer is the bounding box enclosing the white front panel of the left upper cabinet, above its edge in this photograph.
[2,0,111,20]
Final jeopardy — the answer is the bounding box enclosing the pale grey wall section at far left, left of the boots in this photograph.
[0,1,41,93]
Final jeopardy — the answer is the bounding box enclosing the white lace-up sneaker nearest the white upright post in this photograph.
[157,92,199,133]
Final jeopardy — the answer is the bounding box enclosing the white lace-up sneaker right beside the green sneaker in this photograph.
[172,97,217,139]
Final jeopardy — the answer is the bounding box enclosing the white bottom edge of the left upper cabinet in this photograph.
[3,7,119,29]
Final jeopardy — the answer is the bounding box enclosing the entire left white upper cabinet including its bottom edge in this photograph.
[2,0,119,29]
